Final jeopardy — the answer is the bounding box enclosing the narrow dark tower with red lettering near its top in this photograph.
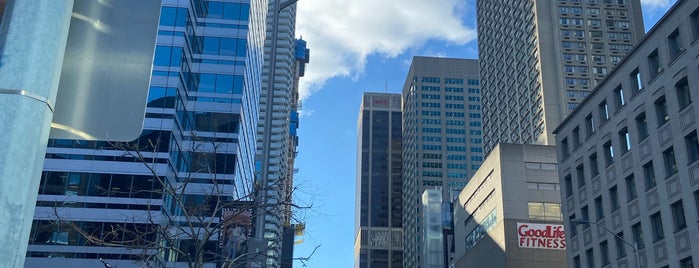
[354,92,404,268]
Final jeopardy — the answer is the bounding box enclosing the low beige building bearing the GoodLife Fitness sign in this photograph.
[450,143,566,268]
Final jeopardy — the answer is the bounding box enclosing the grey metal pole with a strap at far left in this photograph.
[0,0,73,267]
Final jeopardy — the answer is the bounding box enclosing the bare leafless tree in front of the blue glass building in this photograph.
[36,135,315,268]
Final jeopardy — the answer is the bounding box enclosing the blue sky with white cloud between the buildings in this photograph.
[294,0,675,268]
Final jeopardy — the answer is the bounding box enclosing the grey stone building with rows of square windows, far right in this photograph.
[554,0,699,268]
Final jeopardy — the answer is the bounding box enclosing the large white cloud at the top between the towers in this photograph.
[296,0,476,99]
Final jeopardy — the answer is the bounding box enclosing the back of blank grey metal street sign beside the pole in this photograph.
[50,0,161,141]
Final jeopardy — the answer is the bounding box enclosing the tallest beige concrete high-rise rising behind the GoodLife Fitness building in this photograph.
[476,0,643,154]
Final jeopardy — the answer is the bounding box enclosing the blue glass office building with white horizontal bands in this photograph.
[26,0,267,267]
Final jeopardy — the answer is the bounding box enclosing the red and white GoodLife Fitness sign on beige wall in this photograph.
[517,222,566,250]
